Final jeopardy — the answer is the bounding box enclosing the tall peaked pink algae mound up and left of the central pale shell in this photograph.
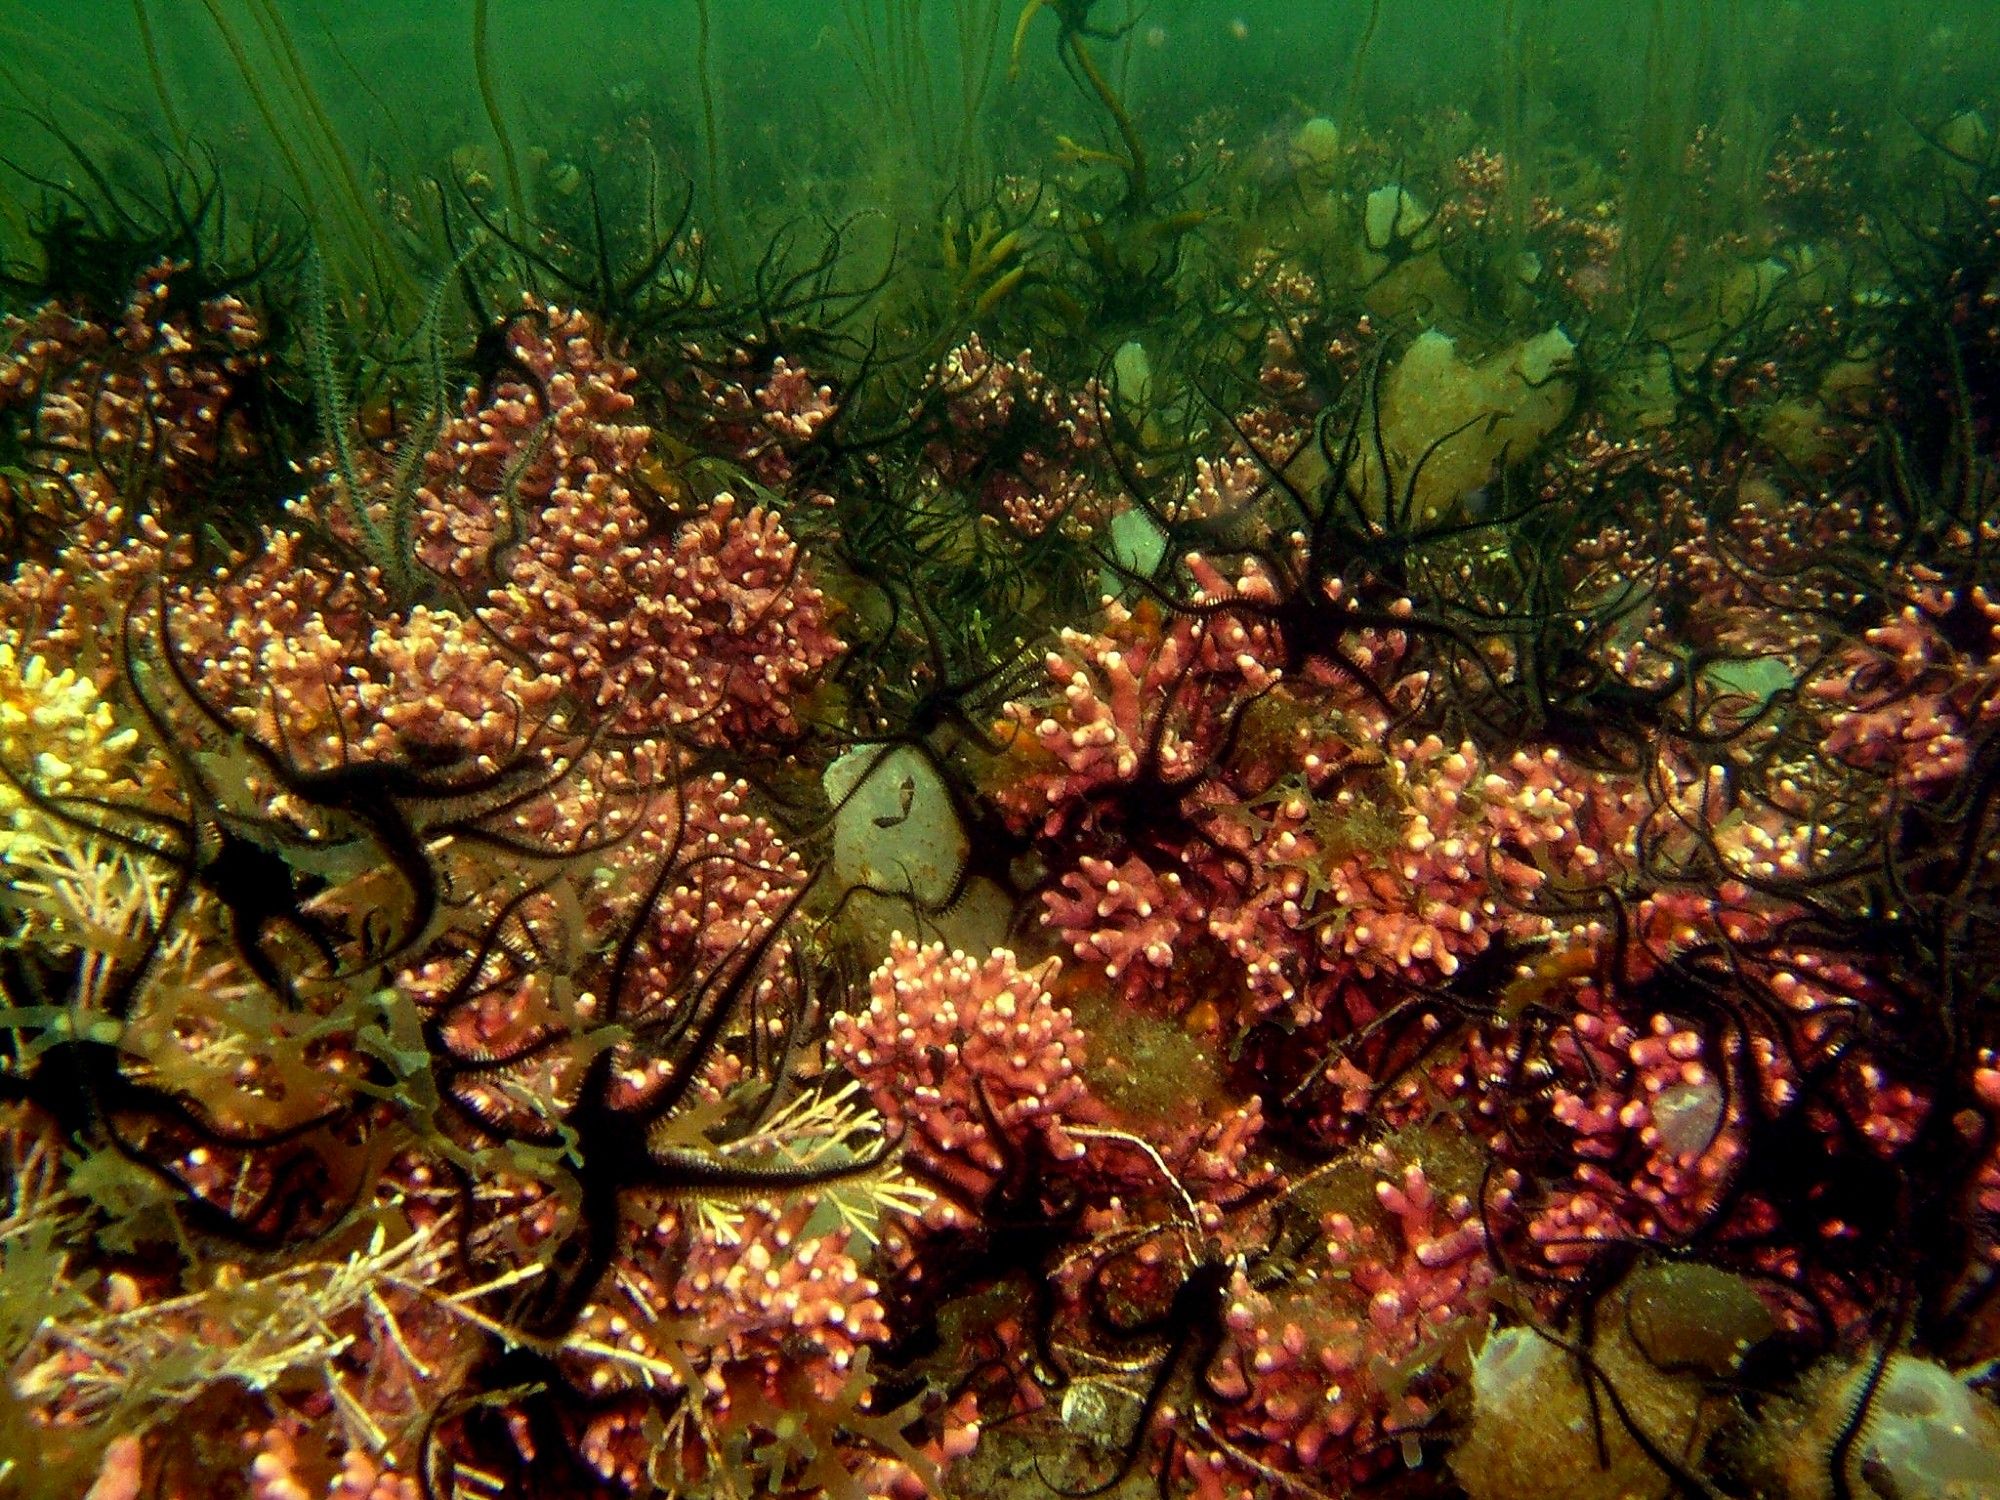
[414,308,840,744]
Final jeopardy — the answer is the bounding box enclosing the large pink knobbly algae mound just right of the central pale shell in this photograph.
[996,558,1592,1022]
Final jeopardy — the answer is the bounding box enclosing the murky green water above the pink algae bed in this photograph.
[0,0,2000,300]
